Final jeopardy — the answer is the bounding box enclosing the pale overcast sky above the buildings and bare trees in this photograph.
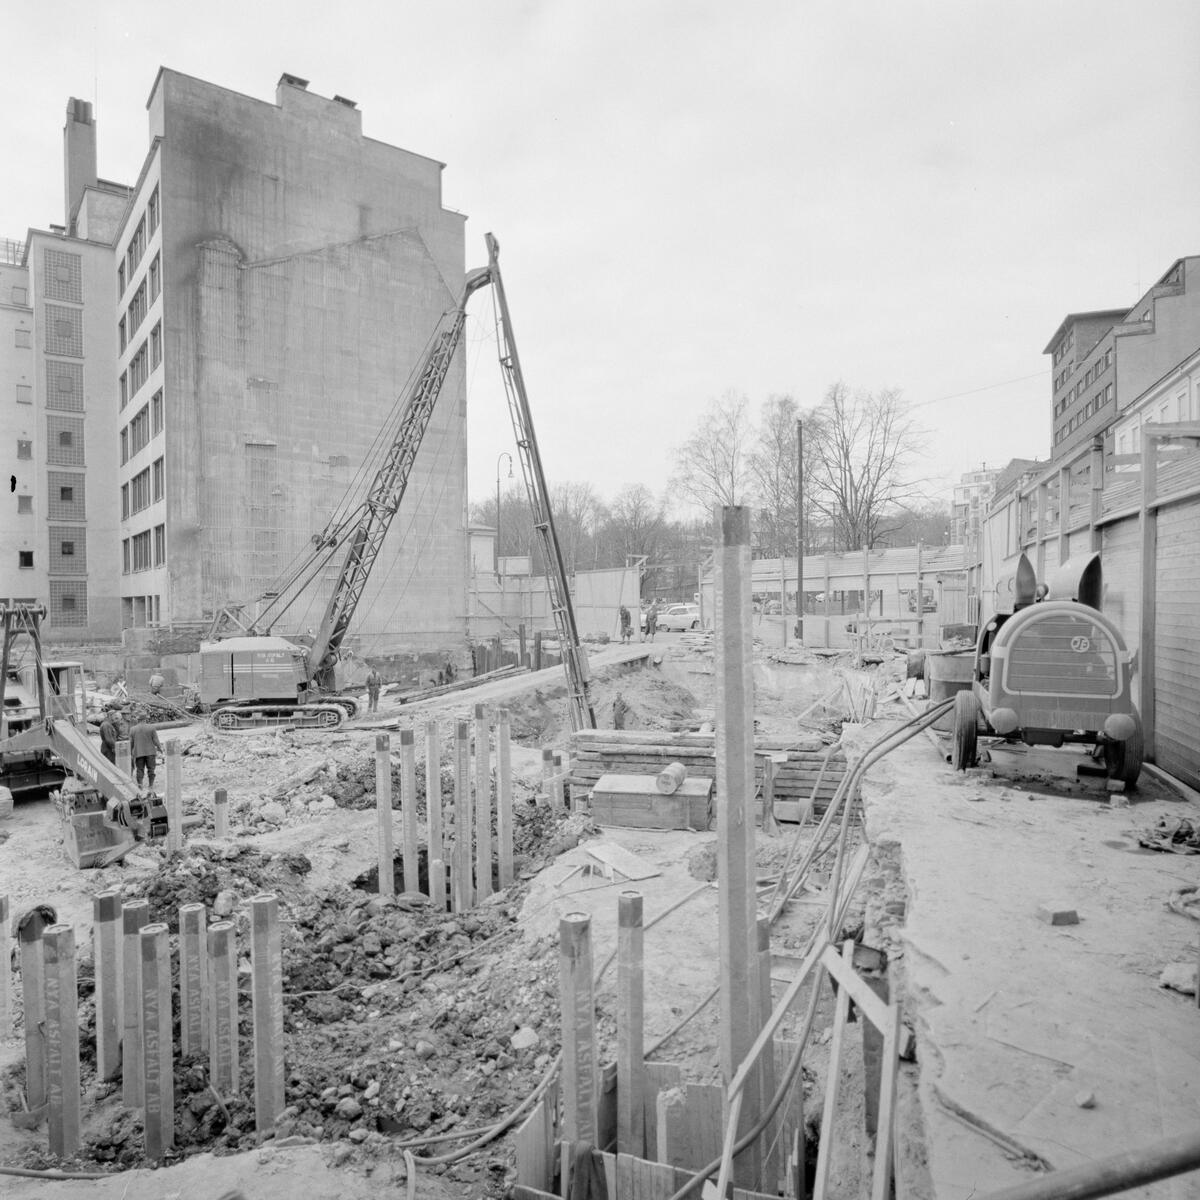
[0,0,1200,511]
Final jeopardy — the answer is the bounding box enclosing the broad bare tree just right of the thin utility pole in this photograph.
[805,382,920,550]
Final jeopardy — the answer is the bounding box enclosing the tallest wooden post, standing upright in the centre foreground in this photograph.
[715,506,762,1188]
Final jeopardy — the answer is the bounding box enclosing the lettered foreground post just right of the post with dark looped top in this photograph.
[42,925,79,1158]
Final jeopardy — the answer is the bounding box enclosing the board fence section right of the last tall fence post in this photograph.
[1152,500,1200,787]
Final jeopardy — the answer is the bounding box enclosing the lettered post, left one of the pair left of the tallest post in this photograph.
[558,912,599,1145]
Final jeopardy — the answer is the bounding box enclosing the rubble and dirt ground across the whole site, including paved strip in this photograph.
[0,634,1200,1200]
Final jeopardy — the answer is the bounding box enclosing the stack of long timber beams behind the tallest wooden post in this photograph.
[568,730,846,821]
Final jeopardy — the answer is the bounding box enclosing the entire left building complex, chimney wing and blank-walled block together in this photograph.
[0,75,467,654]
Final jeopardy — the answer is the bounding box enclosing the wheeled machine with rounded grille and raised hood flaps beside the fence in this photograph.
[950,553,1144,787]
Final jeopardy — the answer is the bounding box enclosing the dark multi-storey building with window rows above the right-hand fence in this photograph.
[1044,257,1200,458]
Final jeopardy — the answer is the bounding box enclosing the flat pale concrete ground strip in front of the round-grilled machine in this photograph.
[863,725,1200,1200]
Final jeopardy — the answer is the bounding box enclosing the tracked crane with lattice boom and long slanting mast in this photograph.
[200,226,595,731]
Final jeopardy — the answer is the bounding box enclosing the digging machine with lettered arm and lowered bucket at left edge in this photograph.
[0,605,167,868]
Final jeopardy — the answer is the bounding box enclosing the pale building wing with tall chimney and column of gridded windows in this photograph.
[0,100,128,637]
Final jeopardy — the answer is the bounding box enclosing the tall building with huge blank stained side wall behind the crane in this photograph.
[113,70,467,654]
